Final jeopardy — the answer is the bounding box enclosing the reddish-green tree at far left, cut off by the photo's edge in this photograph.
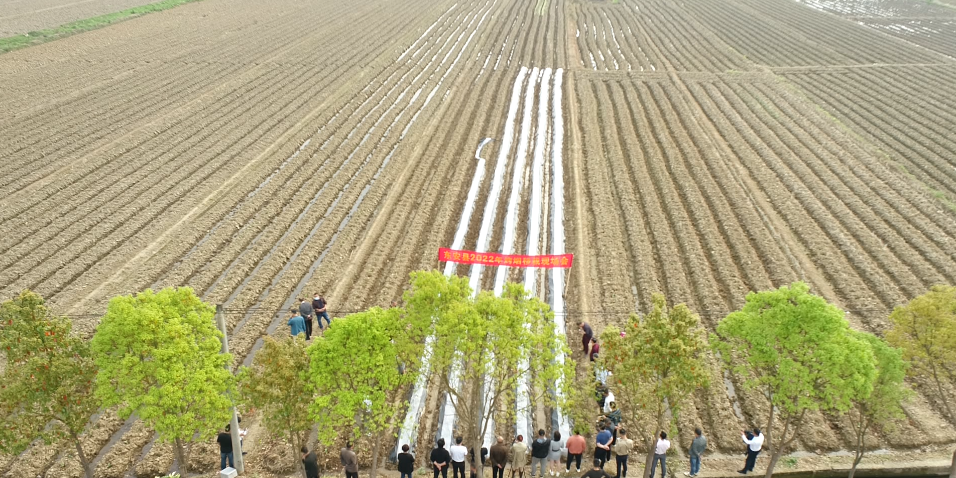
[0,291,98,478]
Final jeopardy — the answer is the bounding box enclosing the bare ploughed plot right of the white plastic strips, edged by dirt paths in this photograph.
[577,73,953,450]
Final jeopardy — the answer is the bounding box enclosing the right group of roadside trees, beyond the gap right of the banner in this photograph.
[597,282,956,478]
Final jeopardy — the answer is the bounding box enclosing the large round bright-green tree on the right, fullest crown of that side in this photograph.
[717,282,876,478]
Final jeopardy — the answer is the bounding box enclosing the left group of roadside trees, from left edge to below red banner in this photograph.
[0,271,574,478]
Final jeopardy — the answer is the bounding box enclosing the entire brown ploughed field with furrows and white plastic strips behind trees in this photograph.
[0,0,956,478]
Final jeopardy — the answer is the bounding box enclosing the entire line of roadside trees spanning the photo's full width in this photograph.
[0,272,956,478]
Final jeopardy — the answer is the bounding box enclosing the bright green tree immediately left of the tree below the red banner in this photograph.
[309,307,422,477]
